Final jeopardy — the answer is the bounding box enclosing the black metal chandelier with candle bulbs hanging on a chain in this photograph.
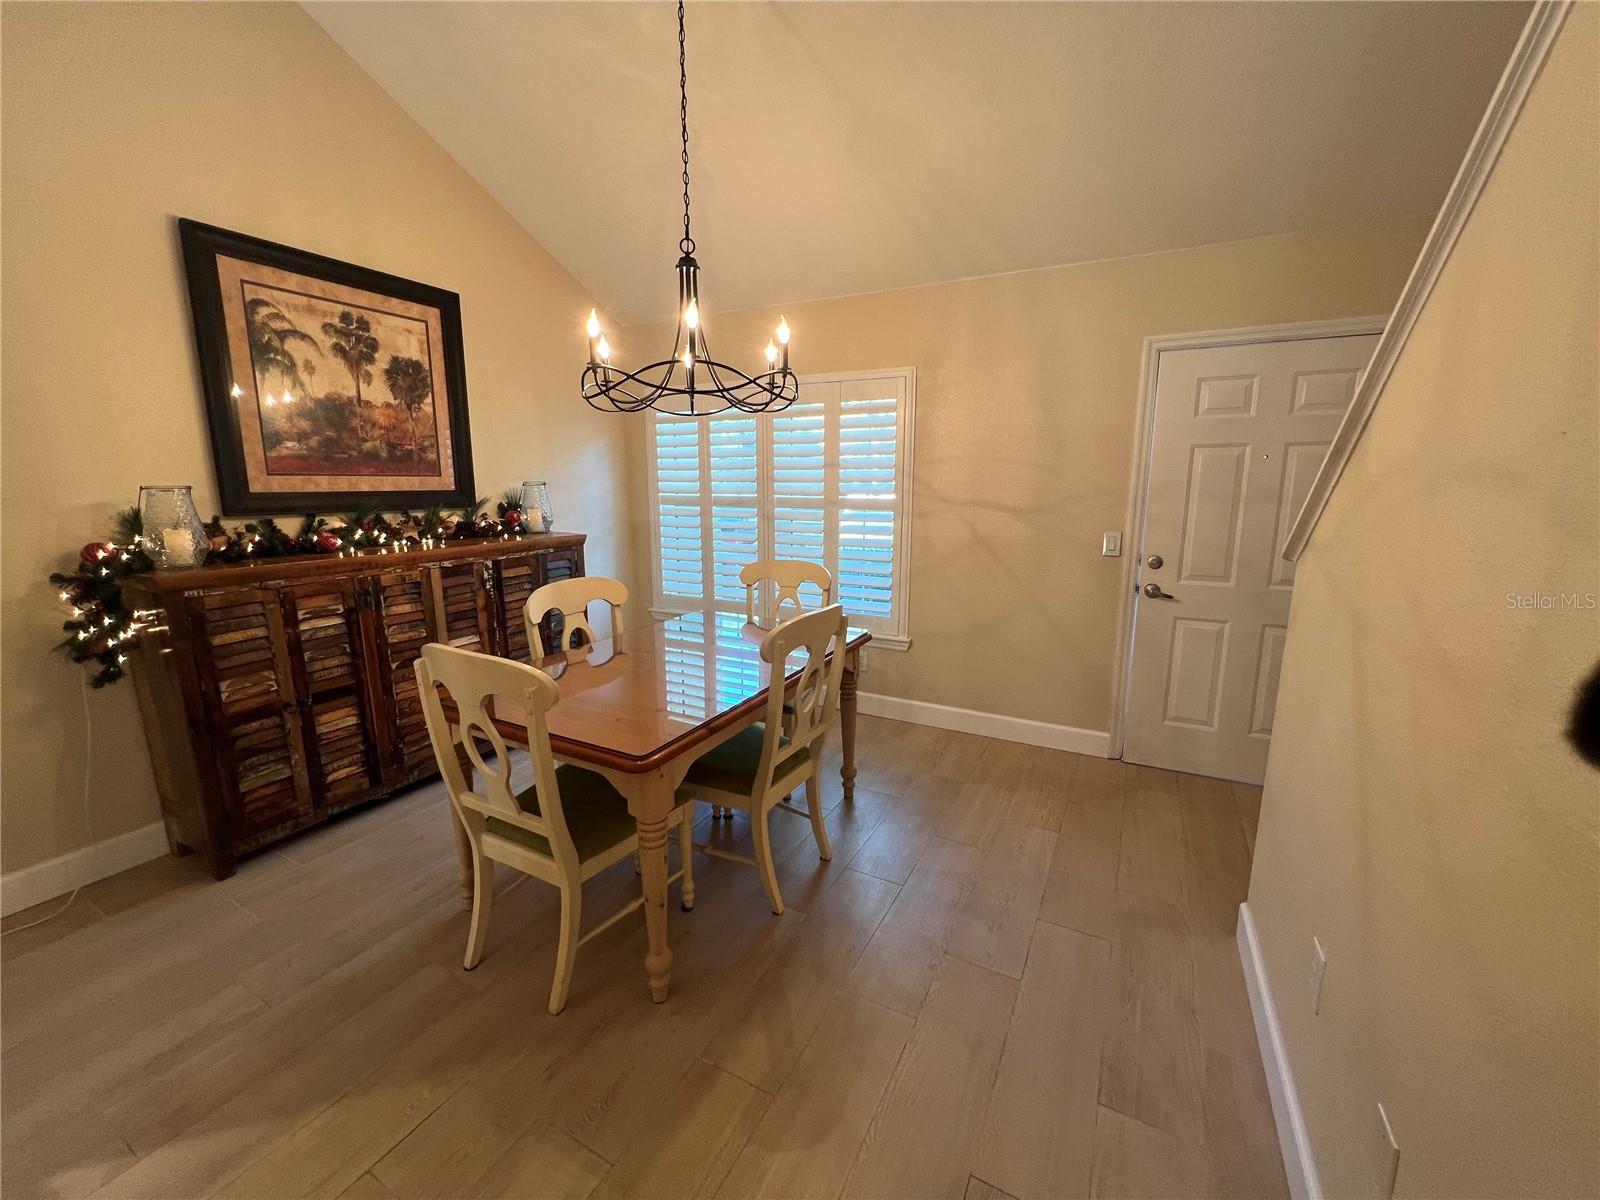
[582,0,800,416]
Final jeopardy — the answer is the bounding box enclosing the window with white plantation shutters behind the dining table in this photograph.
[651,370,915,650]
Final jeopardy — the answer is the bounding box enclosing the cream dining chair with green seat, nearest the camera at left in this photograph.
[416,643,694,1013]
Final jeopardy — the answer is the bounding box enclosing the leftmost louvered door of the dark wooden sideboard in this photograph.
[184,587,314,850]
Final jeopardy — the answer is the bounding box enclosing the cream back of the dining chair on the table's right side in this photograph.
[758,605,848,786]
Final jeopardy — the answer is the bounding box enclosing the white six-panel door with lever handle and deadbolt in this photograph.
[1123,334,1378,782]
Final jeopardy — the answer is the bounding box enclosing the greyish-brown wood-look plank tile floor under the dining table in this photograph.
[0,717,1286,1200]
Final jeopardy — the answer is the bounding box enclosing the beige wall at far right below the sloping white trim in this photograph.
[1250,5,1600,1197]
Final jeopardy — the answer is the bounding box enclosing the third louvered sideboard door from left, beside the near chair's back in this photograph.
[366,570,437,781]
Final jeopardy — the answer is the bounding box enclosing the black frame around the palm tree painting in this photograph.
[178,218,475,517]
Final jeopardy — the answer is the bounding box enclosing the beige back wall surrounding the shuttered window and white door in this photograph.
[616,218,1427,730]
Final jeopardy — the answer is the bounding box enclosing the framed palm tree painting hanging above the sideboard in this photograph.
[178,219,474,517]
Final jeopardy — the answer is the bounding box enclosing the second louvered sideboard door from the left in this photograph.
[282,579,379,811]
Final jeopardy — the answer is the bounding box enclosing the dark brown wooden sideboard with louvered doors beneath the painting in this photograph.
[123,533,584,878]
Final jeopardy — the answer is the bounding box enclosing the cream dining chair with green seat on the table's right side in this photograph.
[678,605,848,914]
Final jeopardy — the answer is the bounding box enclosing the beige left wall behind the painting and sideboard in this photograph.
[0,3,632,870]
